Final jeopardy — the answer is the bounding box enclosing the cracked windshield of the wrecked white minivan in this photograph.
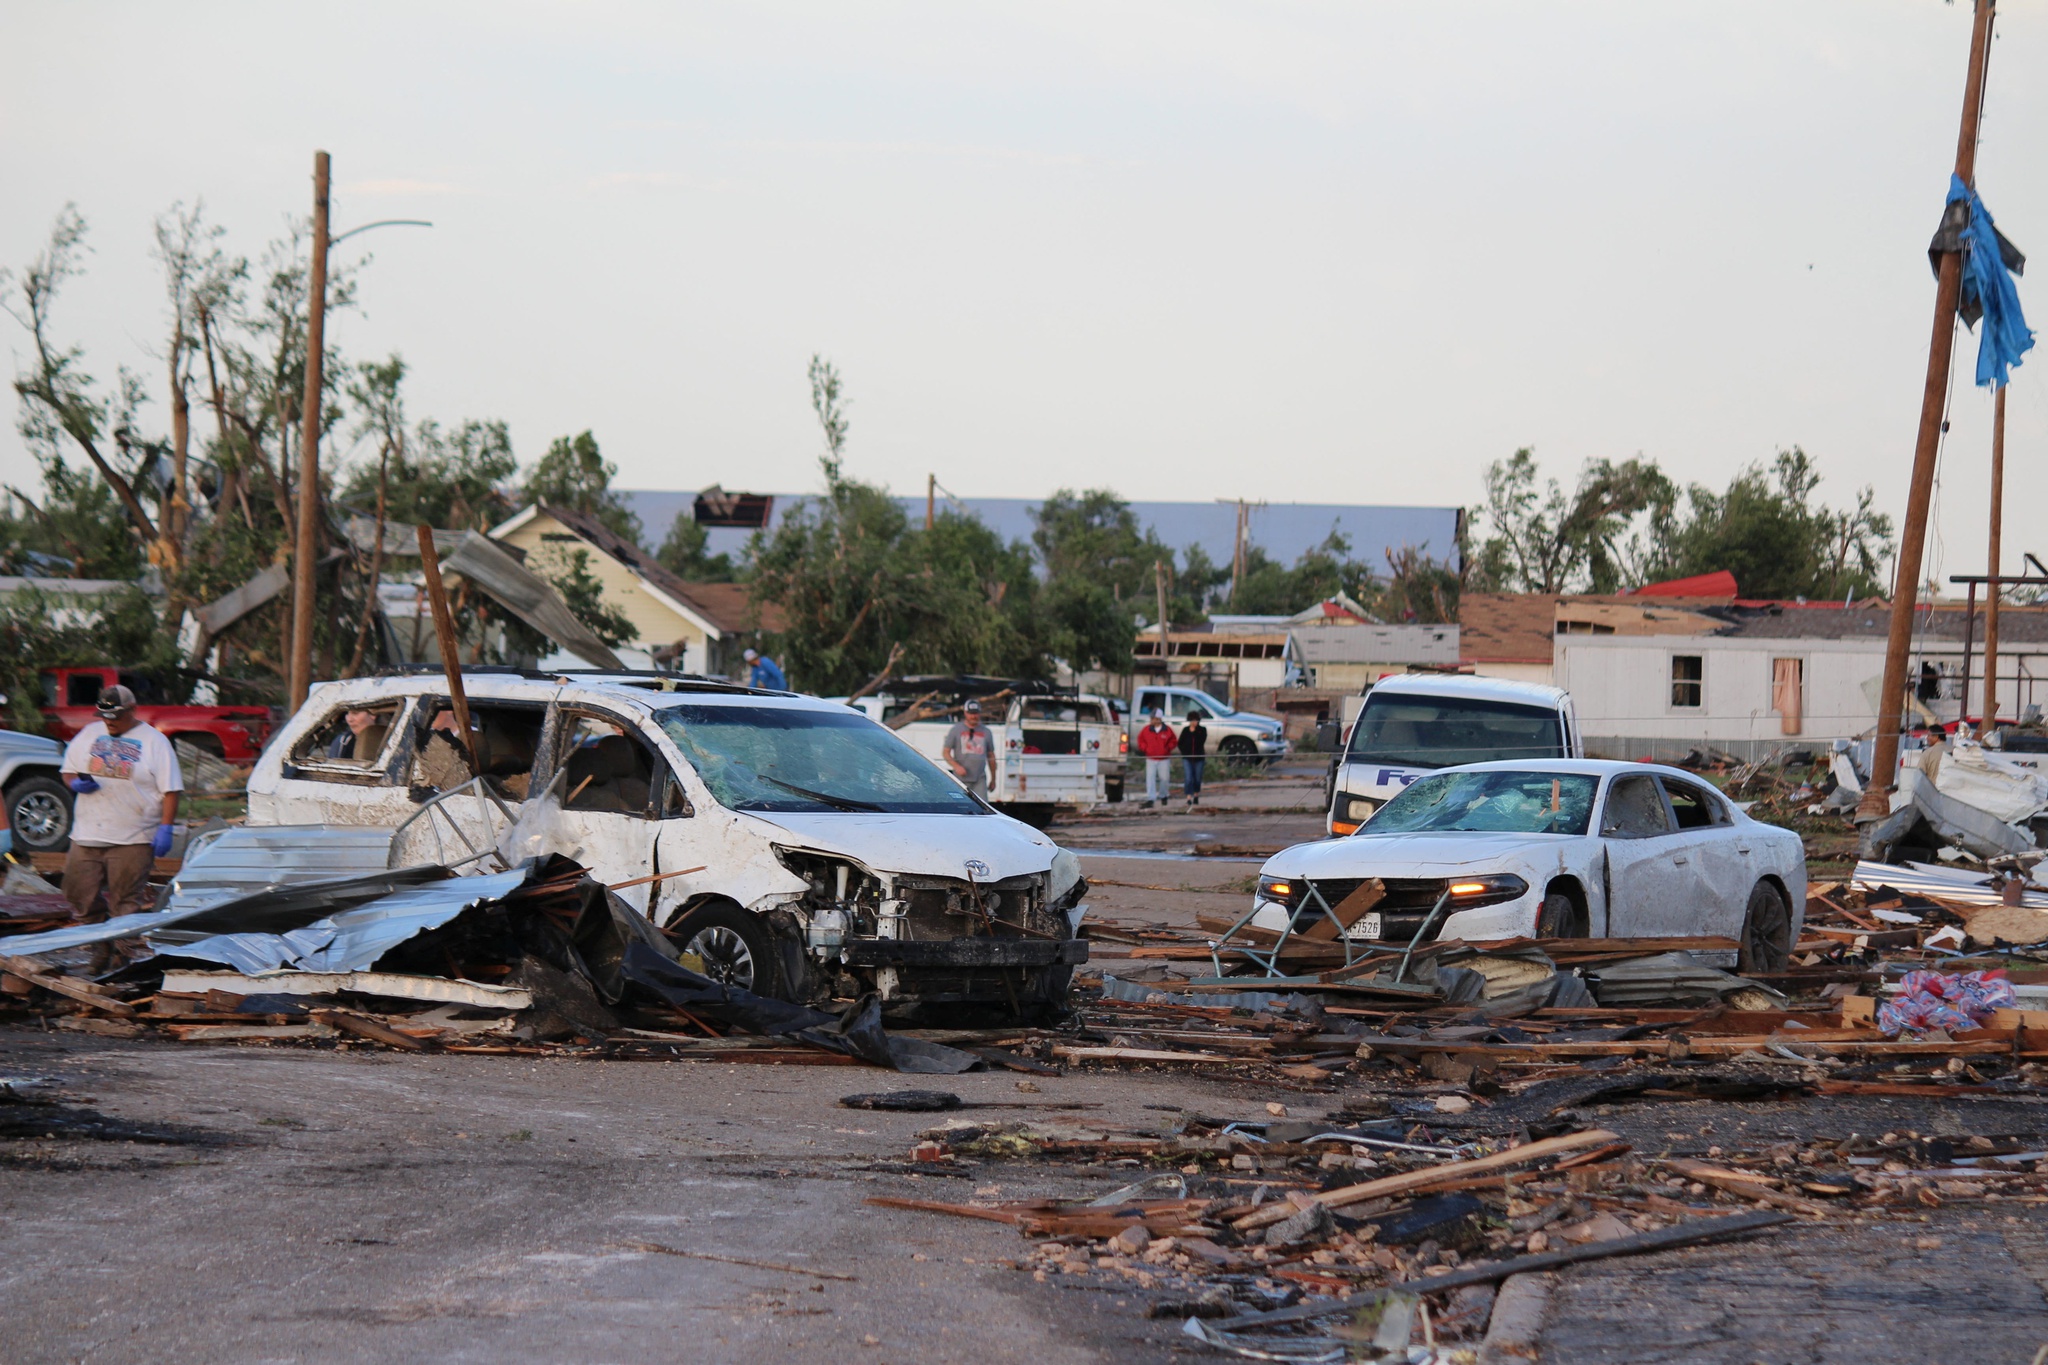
[657,704,983,814]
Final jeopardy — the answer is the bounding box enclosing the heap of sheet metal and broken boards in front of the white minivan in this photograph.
[0,855,981,1072]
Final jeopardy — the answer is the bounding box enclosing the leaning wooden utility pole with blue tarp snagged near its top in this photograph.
[1855,0,1997,819]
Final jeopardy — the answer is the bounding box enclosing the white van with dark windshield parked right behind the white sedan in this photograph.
[1327,673,1585,835]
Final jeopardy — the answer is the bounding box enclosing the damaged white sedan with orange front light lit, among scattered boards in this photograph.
[1251,759,1806,972]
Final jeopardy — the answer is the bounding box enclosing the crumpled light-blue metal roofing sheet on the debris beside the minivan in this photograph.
[160,870,526,974]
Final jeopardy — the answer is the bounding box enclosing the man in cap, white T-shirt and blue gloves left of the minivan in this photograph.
[63,686,184,966]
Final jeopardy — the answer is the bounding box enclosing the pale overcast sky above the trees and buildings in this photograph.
[0,0,2048,589]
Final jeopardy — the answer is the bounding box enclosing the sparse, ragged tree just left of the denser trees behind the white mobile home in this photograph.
[1468,446,1675,593]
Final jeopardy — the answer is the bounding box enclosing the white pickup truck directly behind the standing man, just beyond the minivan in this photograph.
[850,679,1126,829]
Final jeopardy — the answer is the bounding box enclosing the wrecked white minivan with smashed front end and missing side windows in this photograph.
[248,669,1087,1015]
